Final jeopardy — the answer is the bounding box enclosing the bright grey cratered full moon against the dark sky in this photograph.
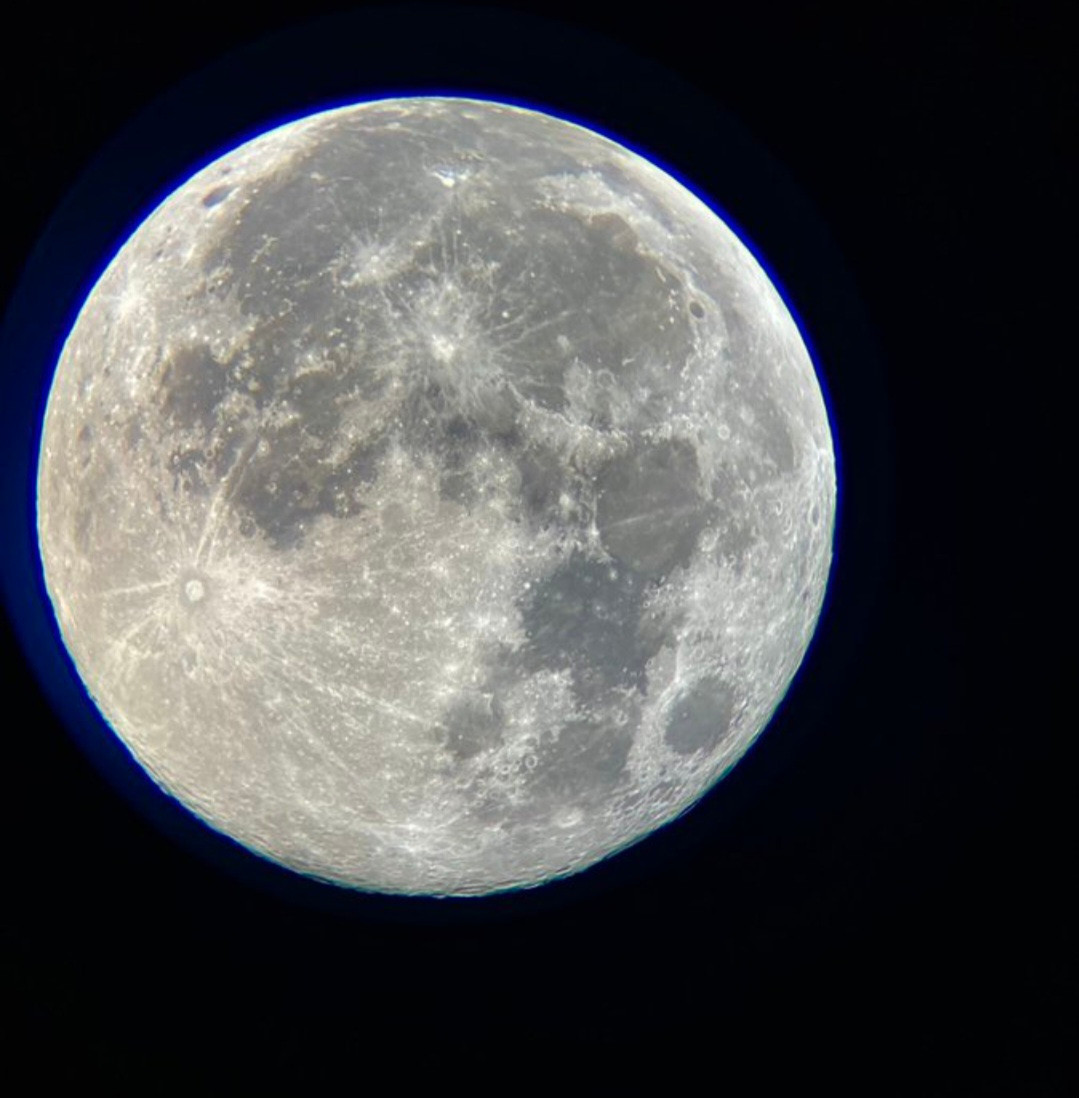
[37,98,836,896]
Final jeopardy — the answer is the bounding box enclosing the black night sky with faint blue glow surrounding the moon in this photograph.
[0,0,1076,1094]
